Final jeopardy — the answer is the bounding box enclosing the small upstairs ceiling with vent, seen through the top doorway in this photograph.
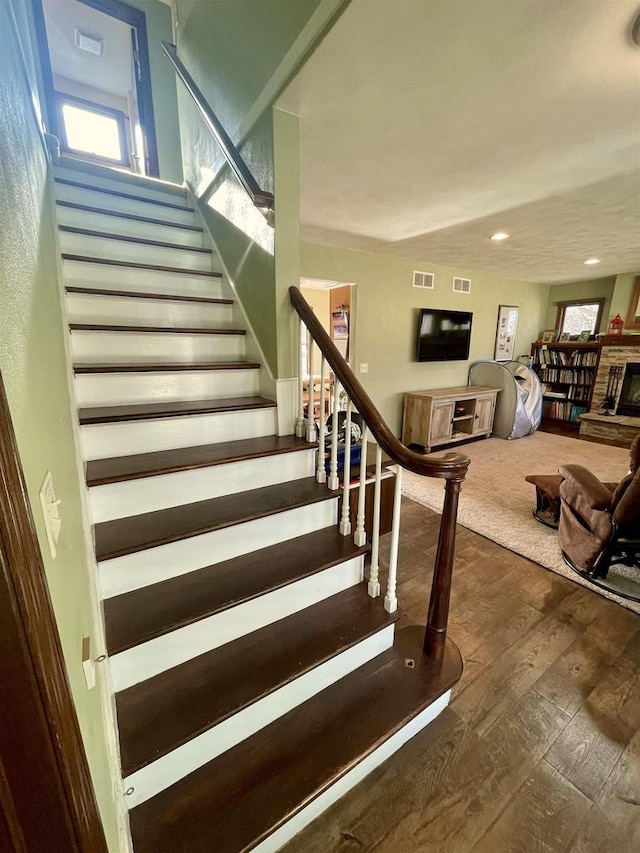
[42,0,134,98]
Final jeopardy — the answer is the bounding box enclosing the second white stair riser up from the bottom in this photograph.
[123,625,394,809]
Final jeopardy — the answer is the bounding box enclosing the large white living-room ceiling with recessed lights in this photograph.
[279,0,640,283]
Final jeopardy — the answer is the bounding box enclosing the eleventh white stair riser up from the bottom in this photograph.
[59,231,213,271]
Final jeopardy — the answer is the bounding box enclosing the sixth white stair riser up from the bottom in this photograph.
[80,408,275,461]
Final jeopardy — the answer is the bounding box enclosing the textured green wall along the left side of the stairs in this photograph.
[0,0,118,851]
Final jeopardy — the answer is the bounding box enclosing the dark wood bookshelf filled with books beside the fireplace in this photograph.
[531,341,600,434]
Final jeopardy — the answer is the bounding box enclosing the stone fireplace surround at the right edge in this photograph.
[580,335,640,447]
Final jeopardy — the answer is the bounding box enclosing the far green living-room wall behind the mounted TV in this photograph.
[302,242,549,434]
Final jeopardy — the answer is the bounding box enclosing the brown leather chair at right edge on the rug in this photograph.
[558,435,640,598]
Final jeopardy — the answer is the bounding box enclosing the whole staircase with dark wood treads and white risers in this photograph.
[55,161,460,853]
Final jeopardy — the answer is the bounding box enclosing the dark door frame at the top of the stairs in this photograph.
[32,0,160,178]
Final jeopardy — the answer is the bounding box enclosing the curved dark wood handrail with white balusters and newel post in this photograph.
[289,287,469,660]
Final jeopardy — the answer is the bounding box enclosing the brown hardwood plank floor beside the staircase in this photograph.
[284,500,640,853]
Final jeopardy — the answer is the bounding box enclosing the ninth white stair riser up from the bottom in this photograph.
[67,293,233,329]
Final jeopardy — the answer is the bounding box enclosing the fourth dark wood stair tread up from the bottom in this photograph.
[94,477,338,560]
